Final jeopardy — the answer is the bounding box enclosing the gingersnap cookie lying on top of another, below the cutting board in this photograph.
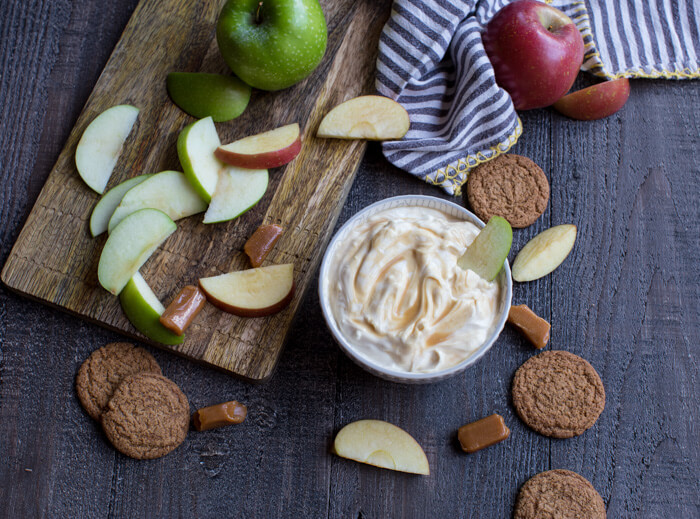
[101,373,190,460]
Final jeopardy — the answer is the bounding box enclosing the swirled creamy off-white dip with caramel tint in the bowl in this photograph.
[326,206,499,373]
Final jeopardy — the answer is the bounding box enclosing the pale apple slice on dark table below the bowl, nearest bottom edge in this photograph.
[333,420,430,476]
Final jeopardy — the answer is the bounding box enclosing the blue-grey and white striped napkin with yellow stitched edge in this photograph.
[376,0,700,195]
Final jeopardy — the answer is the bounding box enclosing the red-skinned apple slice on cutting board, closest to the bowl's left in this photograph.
[199,263,294,317]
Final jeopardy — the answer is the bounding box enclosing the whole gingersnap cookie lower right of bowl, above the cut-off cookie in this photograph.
[512,351,605,438]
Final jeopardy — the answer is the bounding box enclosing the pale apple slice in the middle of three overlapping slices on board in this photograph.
[109,171,207,232]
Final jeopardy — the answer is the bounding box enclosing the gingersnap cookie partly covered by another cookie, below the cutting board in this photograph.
[75,342,162,420]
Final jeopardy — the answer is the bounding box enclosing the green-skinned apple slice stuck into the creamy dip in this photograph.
[457,216,513,281]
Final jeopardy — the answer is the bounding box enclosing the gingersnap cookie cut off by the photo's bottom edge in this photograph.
[514,470,606,519]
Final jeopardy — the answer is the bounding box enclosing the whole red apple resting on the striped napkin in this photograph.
[482,0,583,110]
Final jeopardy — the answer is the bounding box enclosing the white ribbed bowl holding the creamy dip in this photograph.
[318,195,513,384]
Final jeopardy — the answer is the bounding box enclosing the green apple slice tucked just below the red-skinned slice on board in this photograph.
[204,166,269,223]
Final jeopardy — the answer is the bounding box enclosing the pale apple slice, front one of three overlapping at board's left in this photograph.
[97,209,177,295]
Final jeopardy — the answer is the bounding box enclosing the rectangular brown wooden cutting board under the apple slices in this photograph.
[2,0,390,381]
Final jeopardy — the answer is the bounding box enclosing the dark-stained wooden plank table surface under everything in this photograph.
[0,0,700,519]
